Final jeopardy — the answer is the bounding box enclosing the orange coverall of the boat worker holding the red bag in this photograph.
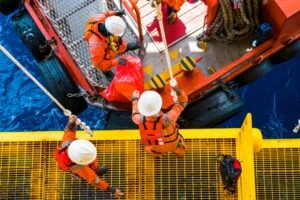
[83,11,127,71]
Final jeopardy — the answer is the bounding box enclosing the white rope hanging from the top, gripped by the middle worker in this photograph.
[156,3,177,101]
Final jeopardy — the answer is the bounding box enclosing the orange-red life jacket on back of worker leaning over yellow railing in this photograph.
[139,116,164,145]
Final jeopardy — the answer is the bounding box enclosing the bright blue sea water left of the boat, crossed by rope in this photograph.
[0,14,105,131]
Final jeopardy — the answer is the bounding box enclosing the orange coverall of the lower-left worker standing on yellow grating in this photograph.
[61,123,112,190]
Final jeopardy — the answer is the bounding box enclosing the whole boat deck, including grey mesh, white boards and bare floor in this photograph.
[38,0,250,88]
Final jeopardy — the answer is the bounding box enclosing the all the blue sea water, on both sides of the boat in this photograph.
[0,15,300,138]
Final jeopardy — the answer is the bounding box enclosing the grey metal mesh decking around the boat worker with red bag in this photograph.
[38,0,137,87]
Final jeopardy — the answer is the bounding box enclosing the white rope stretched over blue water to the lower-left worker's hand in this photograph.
[0,44,93,137]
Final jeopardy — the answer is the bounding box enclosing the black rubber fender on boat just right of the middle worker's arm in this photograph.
[178,90,244,128]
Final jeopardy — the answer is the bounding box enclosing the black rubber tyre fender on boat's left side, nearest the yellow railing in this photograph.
[38,56,87,115]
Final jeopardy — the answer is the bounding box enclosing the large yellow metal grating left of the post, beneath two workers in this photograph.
[0,138,237,200]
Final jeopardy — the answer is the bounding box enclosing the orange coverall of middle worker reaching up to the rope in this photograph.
[132,90,188,158]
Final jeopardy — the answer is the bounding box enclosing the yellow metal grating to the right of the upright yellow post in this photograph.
[255,145,300,200]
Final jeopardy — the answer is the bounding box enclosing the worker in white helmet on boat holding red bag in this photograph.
[83,10,140,72]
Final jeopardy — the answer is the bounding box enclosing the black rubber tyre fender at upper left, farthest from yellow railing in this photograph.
[12,10,51,61]
